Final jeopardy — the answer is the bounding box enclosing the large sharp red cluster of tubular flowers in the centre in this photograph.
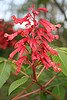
[5,6,61,73]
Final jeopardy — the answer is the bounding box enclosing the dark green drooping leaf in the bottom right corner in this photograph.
[52,85,65,100]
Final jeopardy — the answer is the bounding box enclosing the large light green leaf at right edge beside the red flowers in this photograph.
[52,48,67,76]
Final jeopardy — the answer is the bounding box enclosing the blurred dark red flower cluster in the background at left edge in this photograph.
[0,19,16,49]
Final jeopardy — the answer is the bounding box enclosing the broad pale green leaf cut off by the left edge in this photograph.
[0,61,11,88]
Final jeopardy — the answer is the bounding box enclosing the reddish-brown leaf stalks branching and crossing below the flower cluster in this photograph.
[12,62,60,100]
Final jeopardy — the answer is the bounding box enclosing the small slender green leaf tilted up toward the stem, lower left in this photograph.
[9,76,28,95]
